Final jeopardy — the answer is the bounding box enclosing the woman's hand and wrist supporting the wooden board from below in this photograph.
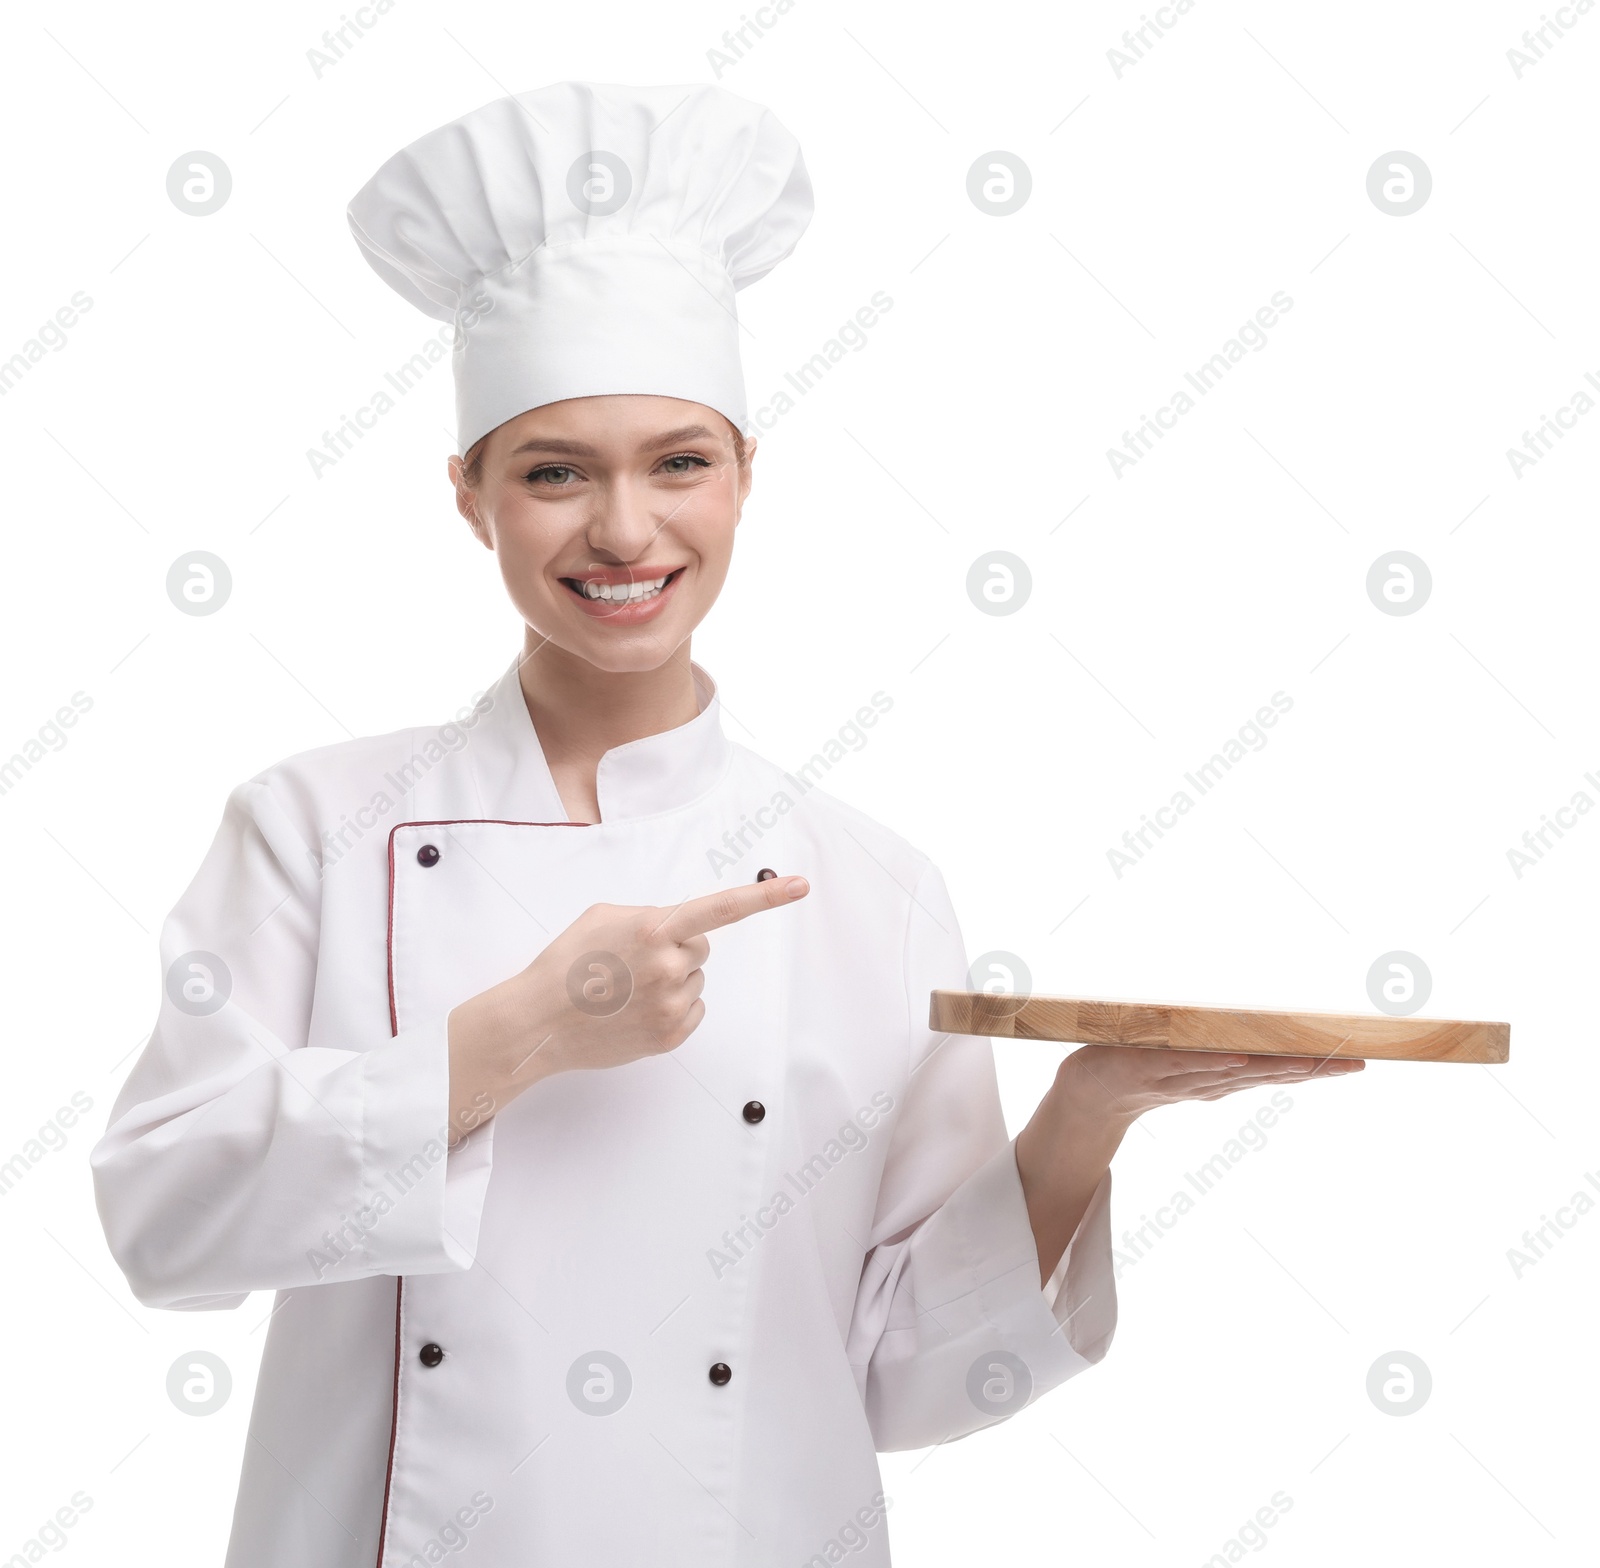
[1016,1045,1366,1285]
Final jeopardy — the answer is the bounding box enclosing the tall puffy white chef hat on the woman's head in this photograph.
[349,82,811,454]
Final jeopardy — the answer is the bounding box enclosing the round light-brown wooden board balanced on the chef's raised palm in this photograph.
[928,990,1510,1062]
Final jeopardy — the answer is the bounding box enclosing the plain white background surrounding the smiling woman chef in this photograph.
[0,0,1600,1568]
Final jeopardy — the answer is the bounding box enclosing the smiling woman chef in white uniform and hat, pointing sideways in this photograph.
[94,82,1358,1568]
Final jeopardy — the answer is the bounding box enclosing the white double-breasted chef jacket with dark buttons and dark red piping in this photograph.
[93,662,1115,1568]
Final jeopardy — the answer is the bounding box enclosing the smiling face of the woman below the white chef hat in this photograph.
[450,395,755,674]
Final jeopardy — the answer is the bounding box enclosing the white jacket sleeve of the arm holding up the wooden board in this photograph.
[848,866,1117,1451]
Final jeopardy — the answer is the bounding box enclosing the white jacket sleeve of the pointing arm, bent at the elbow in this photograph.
[90,776,493,1309]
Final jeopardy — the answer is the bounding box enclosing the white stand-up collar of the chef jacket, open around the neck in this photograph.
[470,653,733,822]
